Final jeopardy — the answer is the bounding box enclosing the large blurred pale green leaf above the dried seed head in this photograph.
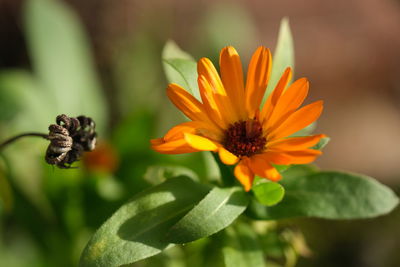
[24,0,107,132]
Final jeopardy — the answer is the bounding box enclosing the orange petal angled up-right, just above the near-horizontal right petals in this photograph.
[267,101,323,141]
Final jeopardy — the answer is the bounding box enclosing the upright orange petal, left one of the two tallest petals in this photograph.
[219,46,247,120]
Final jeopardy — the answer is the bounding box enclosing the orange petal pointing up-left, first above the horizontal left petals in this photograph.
[167,83,209,121]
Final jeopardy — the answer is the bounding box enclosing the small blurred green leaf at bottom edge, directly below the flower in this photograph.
[222,223,265,267]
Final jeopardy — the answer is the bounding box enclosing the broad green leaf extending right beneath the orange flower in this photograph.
[250,171,399,220]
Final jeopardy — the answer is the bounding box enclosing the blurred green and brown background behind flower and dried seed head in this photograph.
[0,0,400,267]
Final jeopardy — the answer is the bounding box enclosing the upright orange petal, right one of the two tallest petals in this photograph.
[245,46,272,118]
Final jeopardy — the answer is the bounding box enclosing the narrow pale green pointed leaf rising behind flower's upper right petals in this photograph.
[264,18,294,101]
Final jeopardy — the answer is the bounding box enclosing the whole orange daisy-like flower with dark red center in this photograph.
[151,46,324,191]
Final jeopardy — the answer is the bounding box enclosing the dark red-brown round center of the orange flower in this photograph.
[222,119,267,157]
